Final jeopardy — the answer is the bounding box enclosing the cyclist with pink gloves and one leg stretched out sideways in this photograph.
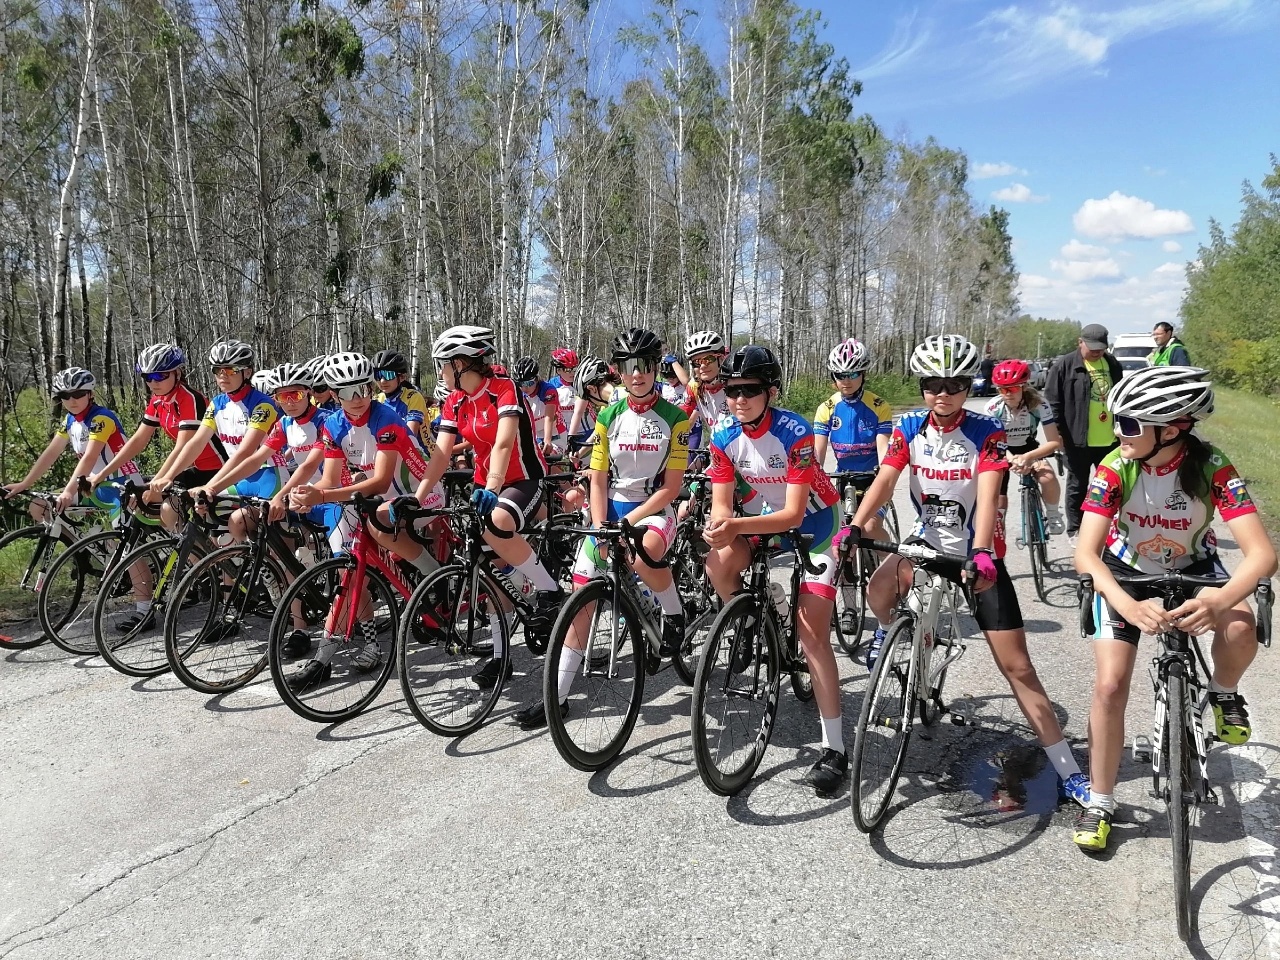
[852,334,1088,805]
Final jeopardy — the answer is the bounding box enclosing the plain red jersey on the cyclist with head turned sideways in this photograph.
[440,376,547,488]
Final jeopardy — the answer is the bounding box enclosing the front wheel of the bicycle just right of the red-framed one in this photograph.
[397,563,515,737]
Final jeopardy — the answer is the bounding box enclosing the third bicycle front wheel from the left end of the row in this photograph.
[93,540,189,678]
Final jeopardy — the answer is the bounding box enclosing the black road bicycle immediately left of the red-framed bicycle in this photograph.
[164,497,330,694]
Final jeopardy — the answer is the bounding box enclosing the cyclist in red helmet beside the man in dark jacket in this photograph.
[984,360,1066,536]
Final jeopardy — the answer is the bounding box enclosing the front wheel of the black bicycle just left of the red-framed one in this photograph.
[164,543,287,694]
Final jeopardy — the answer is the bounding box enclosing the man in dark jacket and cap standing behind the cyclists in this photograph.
[1044,324,1124,545]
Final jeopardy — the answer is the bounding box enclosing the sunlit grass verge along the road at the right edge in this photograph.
[1201,387,1280,544]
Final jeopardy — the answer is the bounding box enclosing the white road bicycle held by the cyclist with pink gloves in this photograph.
[849,538,977,833]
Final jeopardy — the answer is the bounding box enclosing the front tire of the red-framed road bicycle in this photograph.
[268,556,399,723]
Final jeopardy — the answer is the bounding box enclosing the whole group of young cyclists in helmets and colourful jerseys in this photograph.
[0,325,1276,851]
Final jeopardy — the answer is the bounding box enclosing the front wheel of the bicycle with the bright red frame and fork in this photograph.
[268,557,399,723]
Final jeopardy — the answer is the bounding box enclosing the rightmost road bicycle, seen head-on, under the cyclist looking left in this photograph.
[1079,573,1274,941]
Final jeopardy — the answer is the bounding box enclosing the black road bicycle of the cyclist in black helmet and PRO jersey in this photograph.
[691,530,820,796]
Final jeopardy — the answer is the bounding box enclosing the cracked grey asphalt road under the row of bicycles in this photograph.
[0,407,1280,960]
